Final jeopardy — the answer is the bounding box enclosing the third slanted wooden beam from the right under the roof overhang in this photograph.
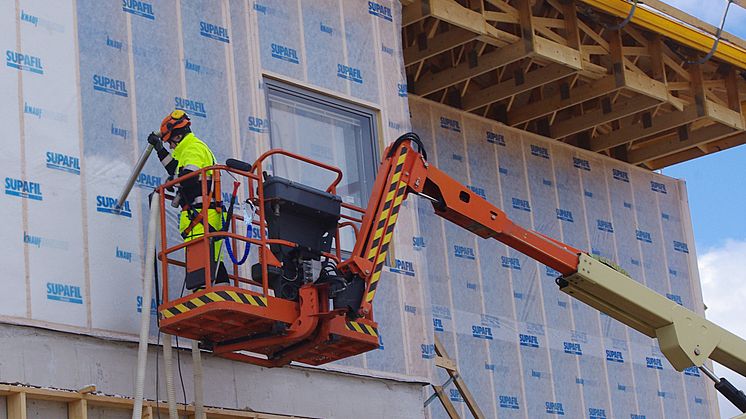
[591,106,704,152]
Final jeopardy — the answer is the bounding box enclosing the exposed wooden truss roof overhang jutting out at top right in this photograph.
[402,0,746,170]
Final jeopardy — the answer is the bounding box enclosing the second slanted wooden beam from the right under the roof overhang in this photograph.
[627,124,736,164]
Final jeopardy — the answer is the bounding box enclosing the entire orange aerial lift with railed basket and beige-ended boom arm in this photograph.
[158,133,746,412]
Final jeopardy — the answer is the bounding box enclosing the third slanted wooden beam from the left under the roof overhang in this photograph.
[461,64,575,111]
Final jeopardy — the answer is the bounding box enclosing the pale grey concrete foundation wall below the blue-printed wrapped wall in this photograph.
[0,325,424,419]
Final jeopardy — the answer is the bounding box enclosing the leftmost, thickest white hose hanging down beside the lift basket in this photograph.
[132,193,161,419]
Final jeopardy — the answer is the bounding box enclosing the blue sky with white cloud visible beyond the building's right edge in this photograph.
[652,0,746,418]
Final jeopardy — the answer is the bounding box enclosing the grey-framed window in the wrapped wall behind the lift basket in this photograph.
[265,80,378,251]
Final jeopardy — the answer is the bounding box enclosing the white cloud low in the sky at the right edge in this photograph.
[698,240,746,418]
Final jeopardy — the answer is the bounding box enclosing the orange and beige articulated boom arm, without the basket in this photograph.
[340,133,746,394]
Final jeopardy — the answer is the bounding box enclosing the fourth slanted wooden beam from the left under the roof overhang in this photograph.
[508,75,623,126]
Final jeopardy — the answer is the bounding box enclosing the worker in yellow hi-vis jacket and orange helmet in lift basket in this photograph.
[148,109,228,291]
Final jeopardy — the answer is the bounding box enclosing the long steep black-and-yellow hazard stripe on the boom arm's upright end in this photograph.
[365,147,407,302]
